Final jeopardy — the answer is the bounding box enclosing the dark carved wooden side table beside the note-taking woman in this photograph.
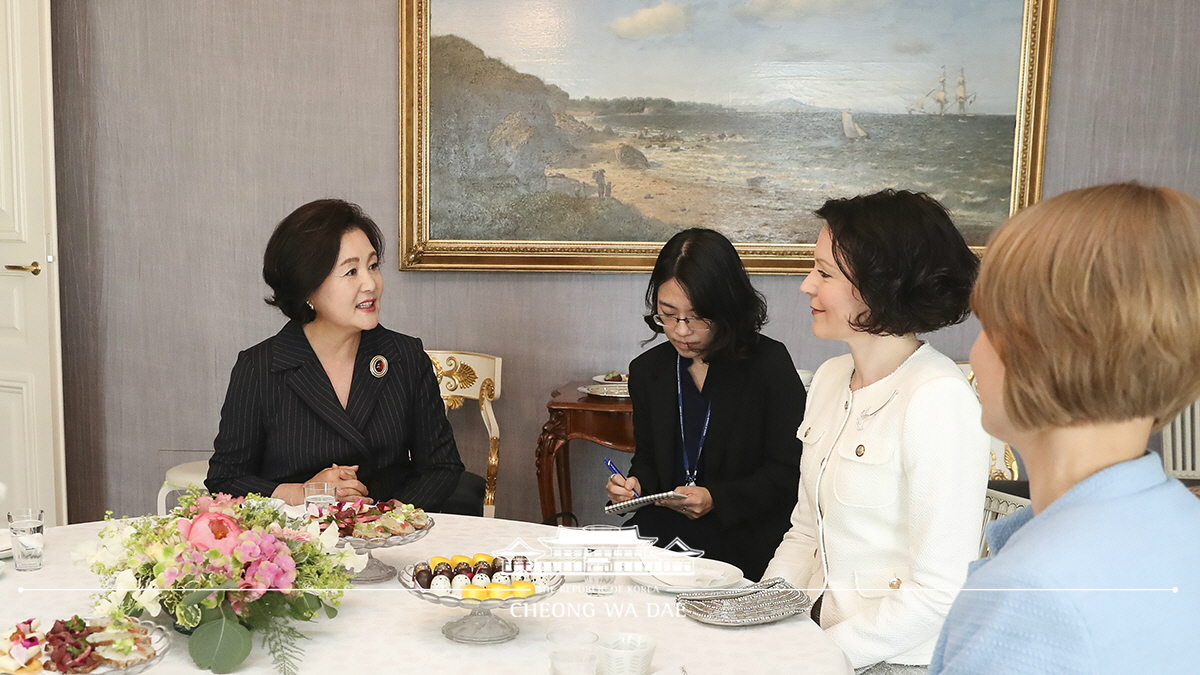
[536,382,634,520]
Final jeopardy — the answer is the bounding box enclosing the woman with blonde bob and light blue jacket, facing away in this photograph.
[930,184,1200,675]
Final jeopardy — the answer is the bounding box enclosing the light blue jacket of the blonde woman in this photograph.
[929,453,1200,675]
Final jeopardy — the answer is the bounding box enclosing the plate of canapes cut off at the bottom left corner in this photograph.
[0,616,170,675]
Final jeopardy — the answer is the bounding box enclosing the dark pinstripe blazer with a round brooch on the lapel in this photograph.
[204,322,463,509]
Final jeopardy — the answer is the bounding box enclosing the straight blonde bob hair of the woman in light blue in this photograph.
[971,184,1200,430]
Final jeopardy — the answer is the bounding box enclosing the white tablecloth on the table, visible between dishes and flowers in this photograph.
[0,515,851,675]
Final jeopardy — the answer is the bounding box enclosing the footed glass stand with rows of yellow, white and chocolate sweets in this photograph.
[400,554,564,644]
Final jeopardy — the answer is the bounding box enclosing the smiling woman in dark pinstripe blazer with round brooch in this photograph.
[204,199,463,509]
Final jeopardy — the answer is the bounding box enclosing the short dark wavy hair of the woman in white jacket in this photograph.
[816,190,979,335]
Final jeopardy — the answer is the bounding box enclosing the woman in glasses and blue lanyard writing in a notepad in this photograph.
[607,228,804,580]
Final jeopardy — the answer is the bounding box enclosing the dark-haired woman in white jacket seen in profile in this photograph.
[764,190,990,673]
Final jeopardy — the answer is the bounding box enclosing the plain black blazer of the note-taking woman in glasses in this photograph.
[629,335,805,571]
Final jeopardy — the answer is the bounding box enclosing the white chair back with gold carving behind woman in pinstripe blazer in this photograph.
[425,350,503,518]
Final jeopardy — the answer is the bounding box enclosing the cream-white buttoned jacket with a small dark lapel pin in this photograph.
[763,344,991,668]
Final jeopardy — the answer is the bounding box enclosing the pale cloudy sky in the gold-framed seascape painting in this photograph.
[430,0,1024,114]
